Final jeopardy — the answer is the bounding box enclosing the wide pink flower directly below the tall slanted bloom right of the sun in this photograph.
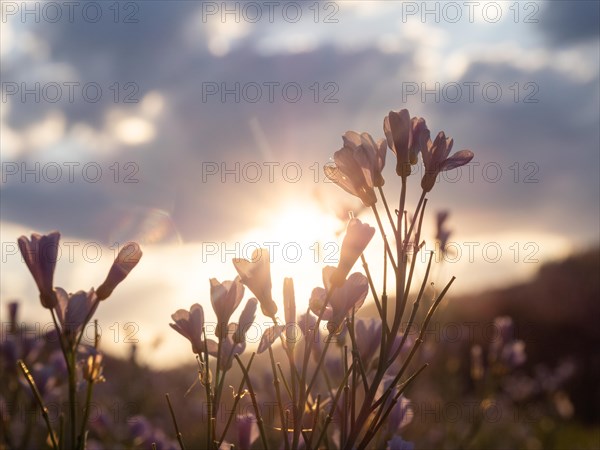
[309,266,369,334]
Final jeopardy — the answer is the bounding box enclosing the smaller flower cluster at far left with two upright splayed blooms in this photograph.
[13,231,142,450]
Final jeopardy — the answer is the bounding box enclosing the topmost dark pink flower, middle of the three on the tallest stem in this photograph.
[383,109,429,177]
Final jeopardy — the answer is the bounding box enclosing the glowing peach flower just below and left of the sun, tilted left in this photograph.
[233,248,277,317]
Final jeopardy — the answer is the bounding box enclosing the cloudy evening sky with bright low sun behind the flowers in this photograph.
[0,0,600,366]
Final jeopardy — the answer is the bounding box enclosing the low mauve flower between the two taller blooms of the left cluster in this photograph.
[55,287,98,345]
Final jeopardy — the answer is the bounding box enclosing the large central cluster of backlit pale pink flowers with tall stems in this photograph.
[166,110,473,450]
